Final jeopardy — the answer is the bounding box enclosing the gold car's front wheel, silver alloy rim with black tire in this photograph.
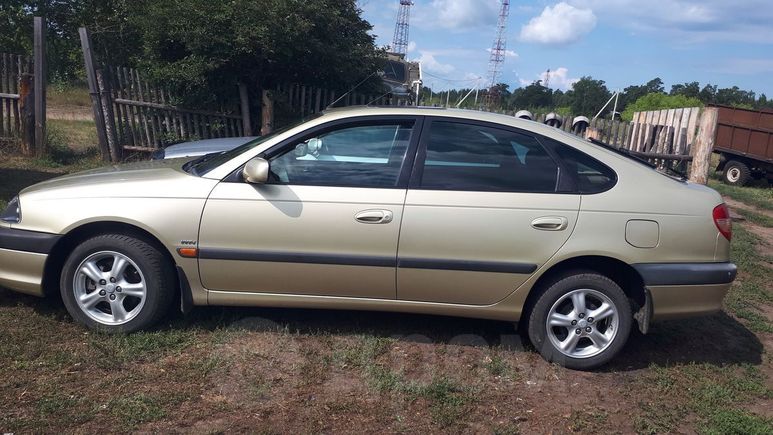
[59,234,176,333]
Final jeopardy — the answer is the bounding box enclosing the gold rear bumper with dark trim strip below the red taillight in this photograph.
[633,263,736,320]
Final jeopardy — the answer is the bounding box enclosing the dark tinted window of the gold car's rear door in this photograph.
[421,122,558,192]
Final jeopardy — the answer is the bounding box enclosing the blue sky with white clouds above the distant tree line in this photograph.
[358,0,773,98]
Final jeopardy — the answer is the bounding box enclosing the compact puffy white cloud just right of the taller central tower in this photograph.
[520,2,596,45]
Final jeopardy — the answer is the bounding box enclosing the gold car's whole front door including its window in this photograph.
[199,118,416,299]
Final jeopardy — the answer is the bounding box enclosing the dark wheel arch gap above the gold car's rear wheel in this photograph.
[519,255,647,326]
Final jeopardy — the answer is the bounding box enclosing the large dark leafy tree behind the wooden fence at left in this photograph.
[136,0,383,105]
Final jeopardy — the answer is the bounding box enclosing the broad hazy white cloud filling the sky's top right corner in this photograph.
[566,0,773,45]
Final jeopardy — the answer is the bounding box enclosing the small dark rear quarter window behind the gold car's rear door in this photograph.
[552,141,617,194]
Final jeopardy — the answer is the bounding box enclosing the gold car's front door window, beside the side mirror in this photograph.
[269,124,411,187]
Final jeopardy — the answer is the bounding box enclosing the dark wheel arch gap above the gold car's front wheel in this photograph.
[42,221,177,298]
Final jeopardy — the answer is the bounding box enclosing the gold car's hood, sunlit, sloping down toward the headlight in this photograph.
[20,158,217,200]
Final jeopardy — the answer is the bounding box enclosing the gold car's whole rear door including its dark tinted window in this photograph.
[397,117,580,305]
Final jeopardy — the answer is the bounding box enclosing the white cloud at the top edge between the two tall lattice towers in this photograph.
[411,0,500,32]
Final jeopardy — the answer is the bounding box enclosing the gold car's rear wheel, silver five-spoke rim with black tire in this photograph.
[528,271,633,370]
